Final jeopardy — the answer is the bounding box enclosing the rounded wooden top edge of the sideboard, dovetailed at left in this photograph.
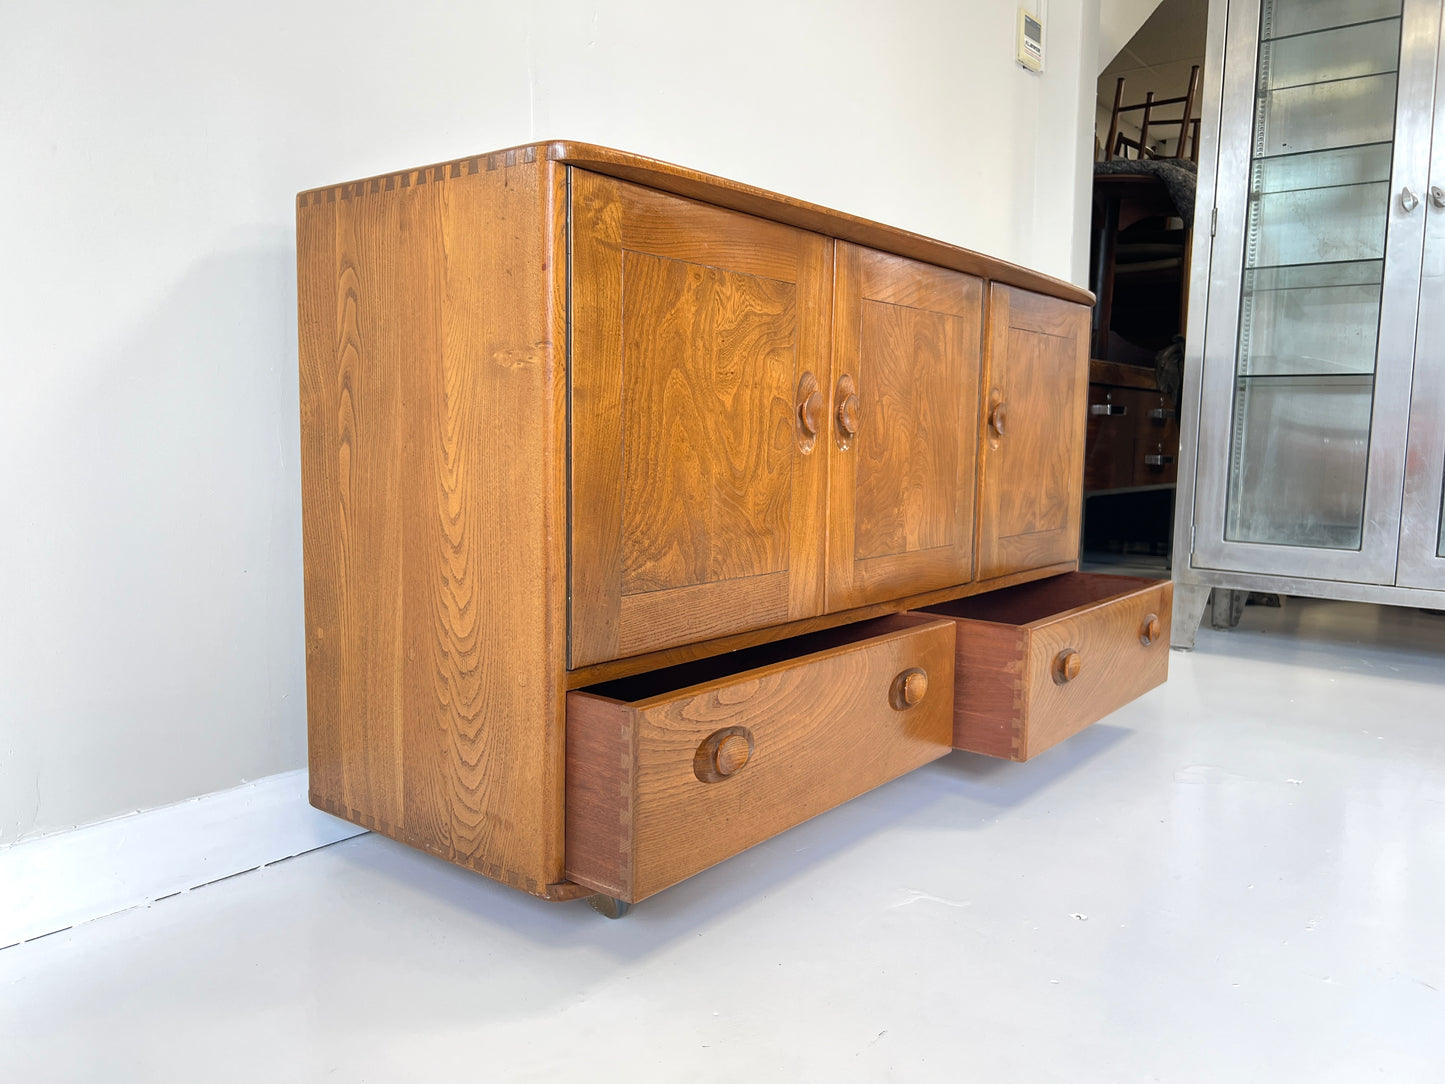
[298,140,1094,305]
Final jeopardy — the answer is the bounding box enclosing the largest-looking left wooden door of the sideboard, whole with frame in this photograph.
[569,169,831,666]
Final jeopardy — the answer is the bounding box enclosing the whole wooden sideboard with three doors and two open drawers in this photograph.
[298,143,1170,908]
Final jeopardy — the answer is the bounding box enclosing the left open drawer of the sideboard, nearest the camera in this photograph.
[566,614,954,902]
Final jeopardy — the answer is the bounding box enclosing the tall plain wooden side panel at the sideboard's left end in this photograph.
[298,156,566,895]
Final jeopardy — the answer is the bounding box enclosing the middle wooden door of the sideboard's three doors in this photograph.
[828,241,983,610]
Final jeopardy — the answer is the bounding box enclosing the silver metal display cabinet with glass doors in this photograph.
[1173,0,1445,646]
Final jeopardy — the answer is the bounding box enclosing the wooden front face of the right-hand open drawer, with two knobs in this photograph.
[1019,581,1173,760]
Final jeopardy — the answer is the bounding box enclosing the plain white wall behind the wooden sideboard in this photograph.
[0,0,1098,843]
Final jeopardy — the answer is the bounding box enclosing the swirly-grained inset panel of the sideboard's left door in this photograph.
[621,251,798,595]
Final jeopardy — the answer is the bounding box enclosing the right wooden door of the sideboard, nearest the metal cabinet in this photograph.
[978,283,1090,580]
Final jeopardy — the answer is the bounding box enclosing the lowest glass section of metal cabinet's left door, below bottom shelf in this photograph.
[1224,376,1374,549]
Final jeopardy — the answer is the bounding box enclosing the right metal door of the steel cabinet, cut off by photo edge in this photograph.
[1396,14,1445,590]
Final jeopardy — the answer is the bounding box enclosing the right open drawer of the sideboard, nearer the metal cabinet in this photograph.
[920,572,1173,760]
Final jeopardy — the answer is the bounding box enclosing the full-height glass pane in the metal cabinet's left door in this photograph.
[1224,0,1400,549]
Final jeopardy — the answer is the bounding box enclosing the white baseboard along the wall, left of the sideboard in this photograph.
[0,770,366,948]
